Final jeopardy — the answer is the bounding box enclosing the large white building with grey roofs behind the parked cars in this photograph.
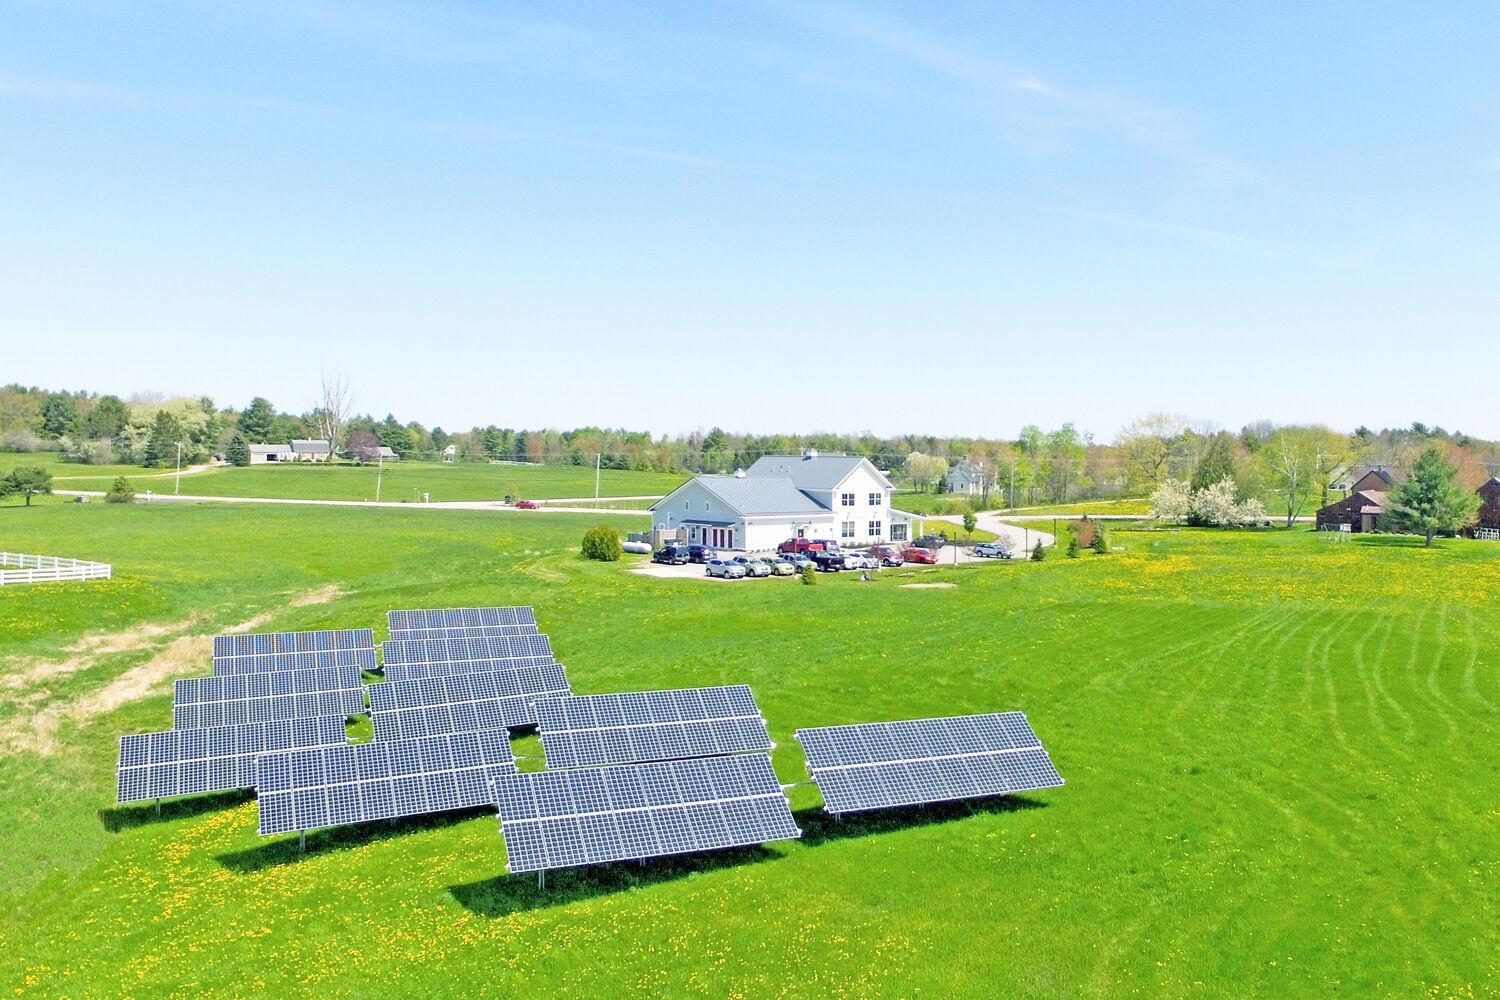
[651,451,911,552]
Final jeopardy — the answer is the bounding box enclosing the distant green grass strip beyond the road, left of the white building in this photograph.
[30,462,687,502]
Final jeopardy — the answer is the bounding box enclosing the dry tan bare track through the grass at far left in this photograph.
[0,583,345,754]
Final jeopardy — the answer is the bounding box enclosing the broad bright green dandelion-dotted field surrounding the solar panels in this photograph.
[0,503,1500,997]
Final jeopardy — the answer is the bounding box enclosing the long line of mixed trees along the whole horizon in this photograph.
[0,378,1500,514]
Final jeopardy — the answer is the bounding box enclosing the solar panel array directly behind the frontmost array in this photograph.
[537,684,771,768]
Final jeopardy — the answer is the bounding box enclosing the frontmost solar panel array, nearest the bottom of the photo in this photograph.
[495,754,803,874]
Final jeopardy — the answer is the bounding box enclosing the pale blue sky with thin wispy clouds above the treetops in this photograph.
[0,0,1500,439]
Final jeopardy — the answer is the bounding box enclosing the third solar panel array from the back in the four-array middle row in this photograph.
[369,663,570,739]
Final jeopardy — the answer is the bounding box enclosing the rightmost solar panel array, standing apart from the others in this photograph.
[797,712,1064,813]
